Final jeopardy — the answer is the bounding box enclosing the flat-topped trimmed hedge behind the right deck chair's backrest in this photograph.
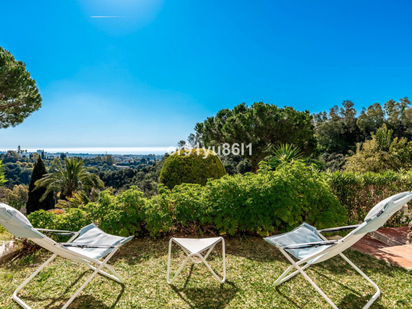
[330,171,412,225]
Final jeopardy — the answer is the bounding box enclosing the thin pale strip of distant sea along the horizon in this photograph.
[0,147,175,155]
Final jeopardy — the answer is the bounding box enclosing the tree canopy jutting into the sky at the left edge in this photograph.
[0,47,42,129]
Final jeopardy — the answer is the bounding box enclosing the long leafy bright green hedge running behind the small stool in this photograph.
[29,162,348,236]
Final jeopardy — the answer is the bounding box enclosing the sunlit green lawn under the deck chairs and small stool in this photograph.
[0,237,412,309]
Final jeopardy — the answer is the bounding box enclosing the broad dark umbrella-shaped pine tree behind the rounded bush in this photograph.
[195,102,316,171]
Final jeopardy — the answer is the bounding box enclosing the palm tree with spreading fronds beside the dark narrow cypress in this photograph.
[35,158,104,201]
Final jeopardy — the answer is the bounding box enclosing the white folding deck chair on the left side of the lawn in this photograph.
[0,203,133,309]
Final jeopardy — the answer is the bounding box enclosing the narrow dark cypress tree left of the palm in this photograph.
[26,156,54,214]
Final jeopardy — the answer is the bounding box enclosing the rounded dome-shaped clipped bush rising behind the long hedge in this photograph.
[159,149,226,189]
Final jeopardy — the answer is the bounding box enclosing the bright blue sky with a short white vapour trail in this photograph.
[0,0,412,149]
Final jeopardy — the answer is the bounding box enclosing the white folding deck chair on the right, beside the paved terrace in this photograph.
[265,192,412,309]
